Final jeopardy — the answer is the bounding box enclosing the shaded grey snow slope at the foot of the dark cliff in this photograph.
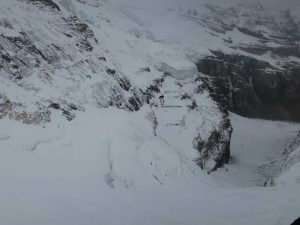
[213,114,300,186]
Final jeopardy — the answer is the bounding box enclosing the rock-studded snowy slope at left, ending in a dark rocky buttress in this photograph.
[1,1,236,171]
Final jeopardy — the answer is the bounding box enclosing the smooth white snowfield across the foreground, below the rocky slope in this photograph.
[0,109,300,225]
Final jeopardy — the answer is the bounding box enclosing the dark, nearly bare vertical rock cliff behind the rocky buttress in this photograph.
[197,52,300,122]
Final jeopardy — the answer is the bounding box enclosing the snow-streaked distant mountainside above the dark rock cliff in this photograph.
[185,3,300,57]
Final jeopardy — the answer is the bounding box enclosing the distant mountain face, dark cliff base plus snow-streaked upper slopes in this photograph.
[186,4,300,121]
